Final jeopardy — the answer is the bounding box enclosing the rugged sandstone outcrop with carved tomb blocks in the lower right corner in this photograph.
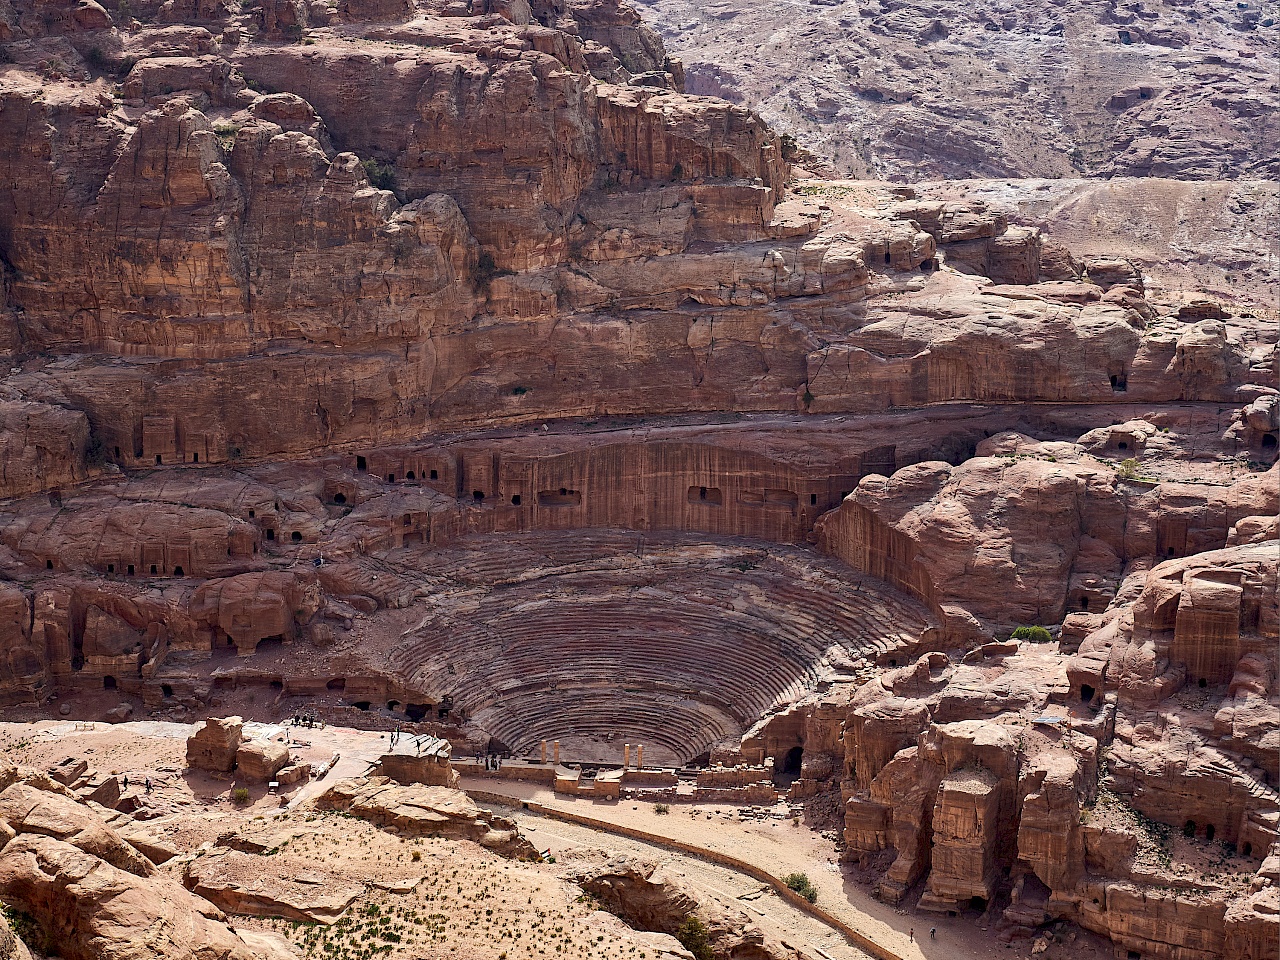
[844,541,1280,960]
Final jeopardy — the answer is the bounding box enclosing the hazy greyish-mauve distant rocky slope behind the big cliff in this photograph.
[645,0,1280,180]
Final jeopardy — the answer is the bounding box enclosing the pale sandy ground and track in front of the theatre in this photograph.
[0,721,1110,960]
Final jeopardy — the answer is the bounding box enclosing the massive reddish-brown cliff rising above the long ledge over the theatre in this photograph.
[0,4,1274,494]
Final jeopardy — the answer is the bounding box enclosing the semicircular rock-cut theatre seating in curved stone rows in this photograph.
[388,530,932,763]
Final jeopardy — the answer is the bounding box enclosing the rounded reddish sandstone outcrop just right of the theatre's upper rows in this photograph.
[818,430,1280,647]
